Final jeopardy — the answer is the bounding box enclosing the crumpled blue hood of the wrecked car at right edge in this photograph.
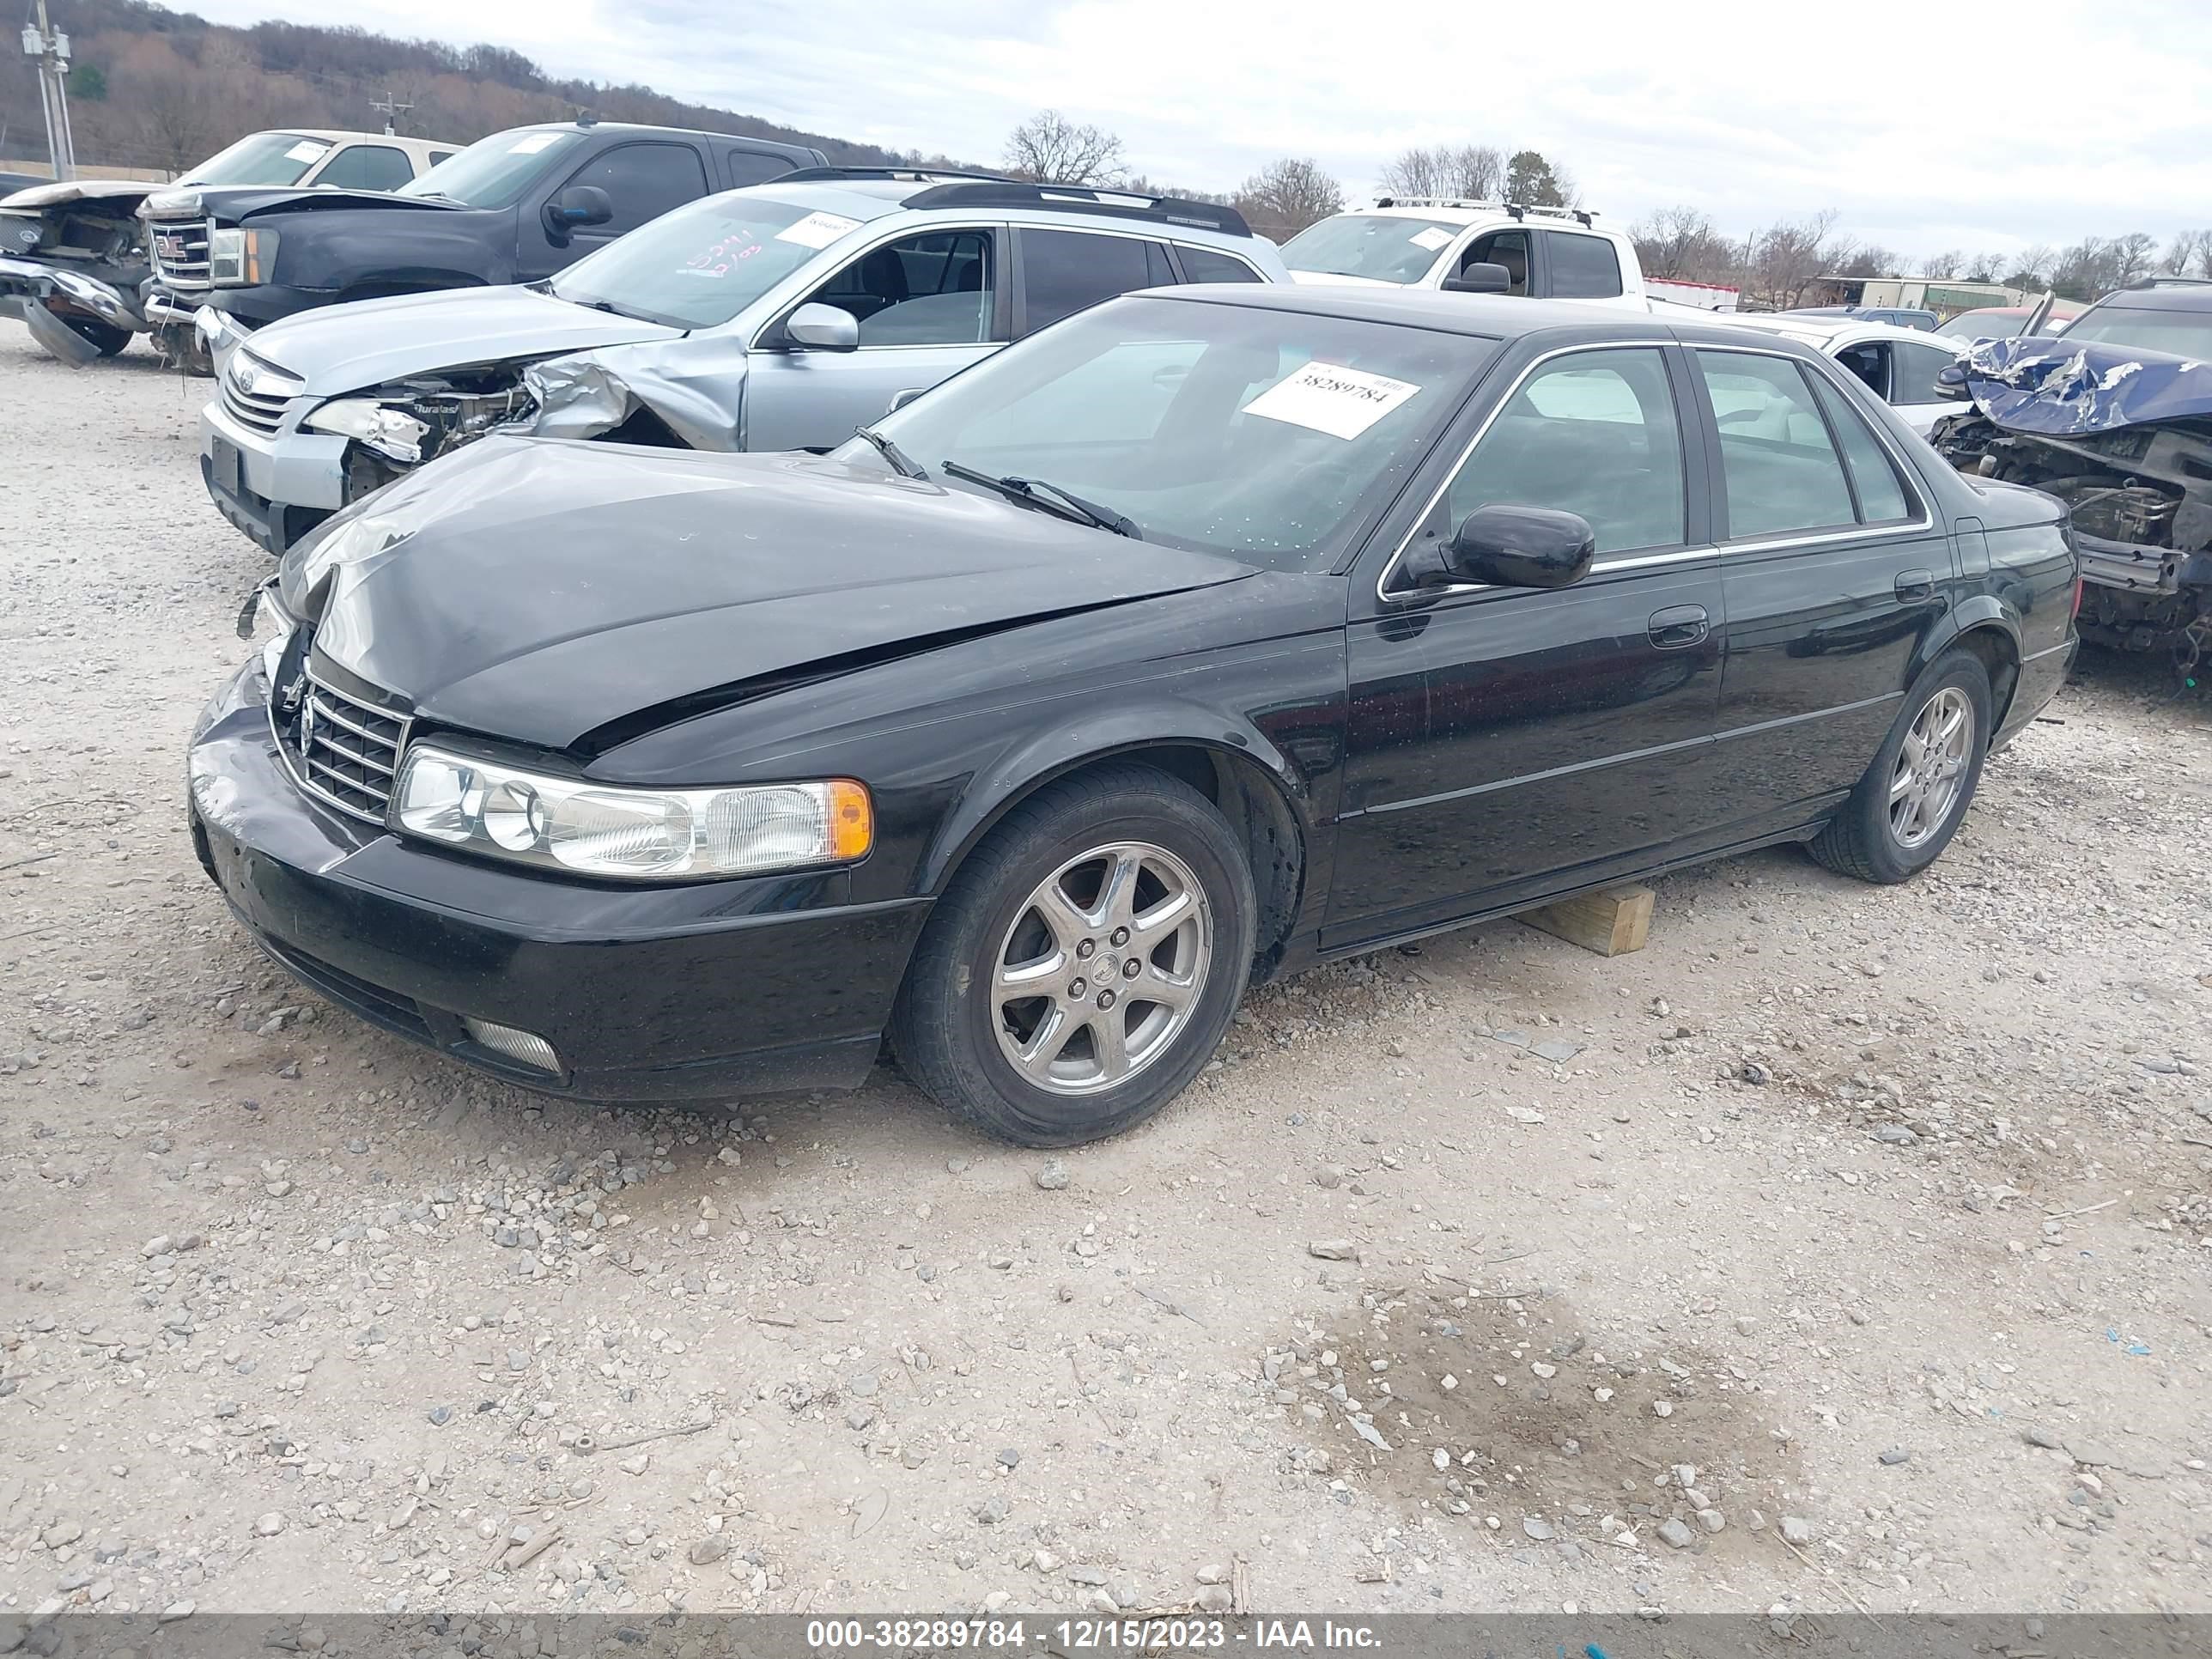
[1938,334,2212,438]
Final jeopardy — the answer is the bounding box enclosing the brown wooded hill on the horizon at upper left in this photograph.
[0,0,969,173]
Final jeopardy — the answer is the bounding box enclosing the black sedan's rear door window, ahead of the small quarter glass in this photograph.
[1697,349,1858,540]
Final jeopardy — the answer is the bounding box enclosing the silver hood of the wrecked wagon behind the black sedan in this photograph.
[240,288,681,398]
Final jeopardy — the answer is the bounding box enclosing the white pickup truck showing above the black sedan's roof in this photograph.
[1283,197,1648,312]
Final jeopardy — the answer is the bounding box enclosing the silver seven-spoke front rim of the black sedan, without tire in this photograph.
[991,841,1214,1095]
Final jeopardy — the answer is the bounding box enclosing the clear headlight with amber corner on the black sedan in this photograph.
[392,744,876,880]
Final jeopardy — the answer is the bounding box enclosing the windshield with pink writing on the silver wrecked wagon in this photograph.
[550,192,860,327]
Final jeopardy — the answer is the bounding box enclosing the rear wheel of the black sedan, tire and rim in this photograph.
[1808,650,1993,884]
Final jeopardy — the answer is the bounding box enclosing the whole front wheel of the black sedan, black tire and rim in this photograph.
[891,765,1256,1146]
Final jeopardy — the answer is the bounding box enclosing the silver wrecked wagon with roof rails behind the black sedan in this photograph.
[199,168,1290,553]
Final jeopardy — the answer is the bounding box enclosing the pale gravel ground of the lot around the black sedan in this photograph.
[0,323,2212,1617]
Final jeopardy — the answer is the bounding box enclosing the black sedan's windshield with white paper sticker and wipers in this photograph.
[838,299,1498,571]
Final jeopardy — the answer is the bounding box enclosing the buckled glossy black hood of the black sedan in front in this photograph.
[281,438,1252,750]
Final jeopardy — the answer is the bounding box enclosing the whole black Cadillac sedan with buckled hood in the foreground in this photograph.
[191,285,2075,1146]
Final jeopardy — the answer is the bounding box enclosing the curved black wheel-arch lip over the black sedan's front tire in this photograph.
[914,696,1318,894]
